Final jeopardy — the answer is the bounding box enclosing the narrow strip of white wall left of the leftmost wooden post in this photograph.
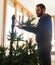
[0,0,4,45]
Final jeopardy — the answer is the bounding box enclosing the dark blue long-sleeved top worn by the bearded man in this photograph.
[23,14,52,46]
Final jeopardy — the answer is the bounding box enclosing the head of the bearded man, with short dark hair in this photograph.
[36,4,46,17]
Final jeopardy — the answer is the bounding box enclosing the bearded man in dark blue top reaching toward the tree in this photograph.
[17,4,52,65]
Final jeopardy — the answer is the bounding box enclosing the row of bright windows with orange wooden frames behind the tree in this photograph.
[4,0,33,46]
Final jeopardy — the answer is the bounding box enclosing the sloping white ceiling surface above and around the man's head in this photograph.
[17,0,55,15]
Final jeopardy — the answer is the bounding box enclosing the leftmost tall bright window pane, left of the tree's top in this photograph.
[4,4,14,45]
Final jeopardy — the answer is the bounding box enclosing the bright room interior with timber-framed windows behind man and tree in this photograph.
[0,0,55,65]
